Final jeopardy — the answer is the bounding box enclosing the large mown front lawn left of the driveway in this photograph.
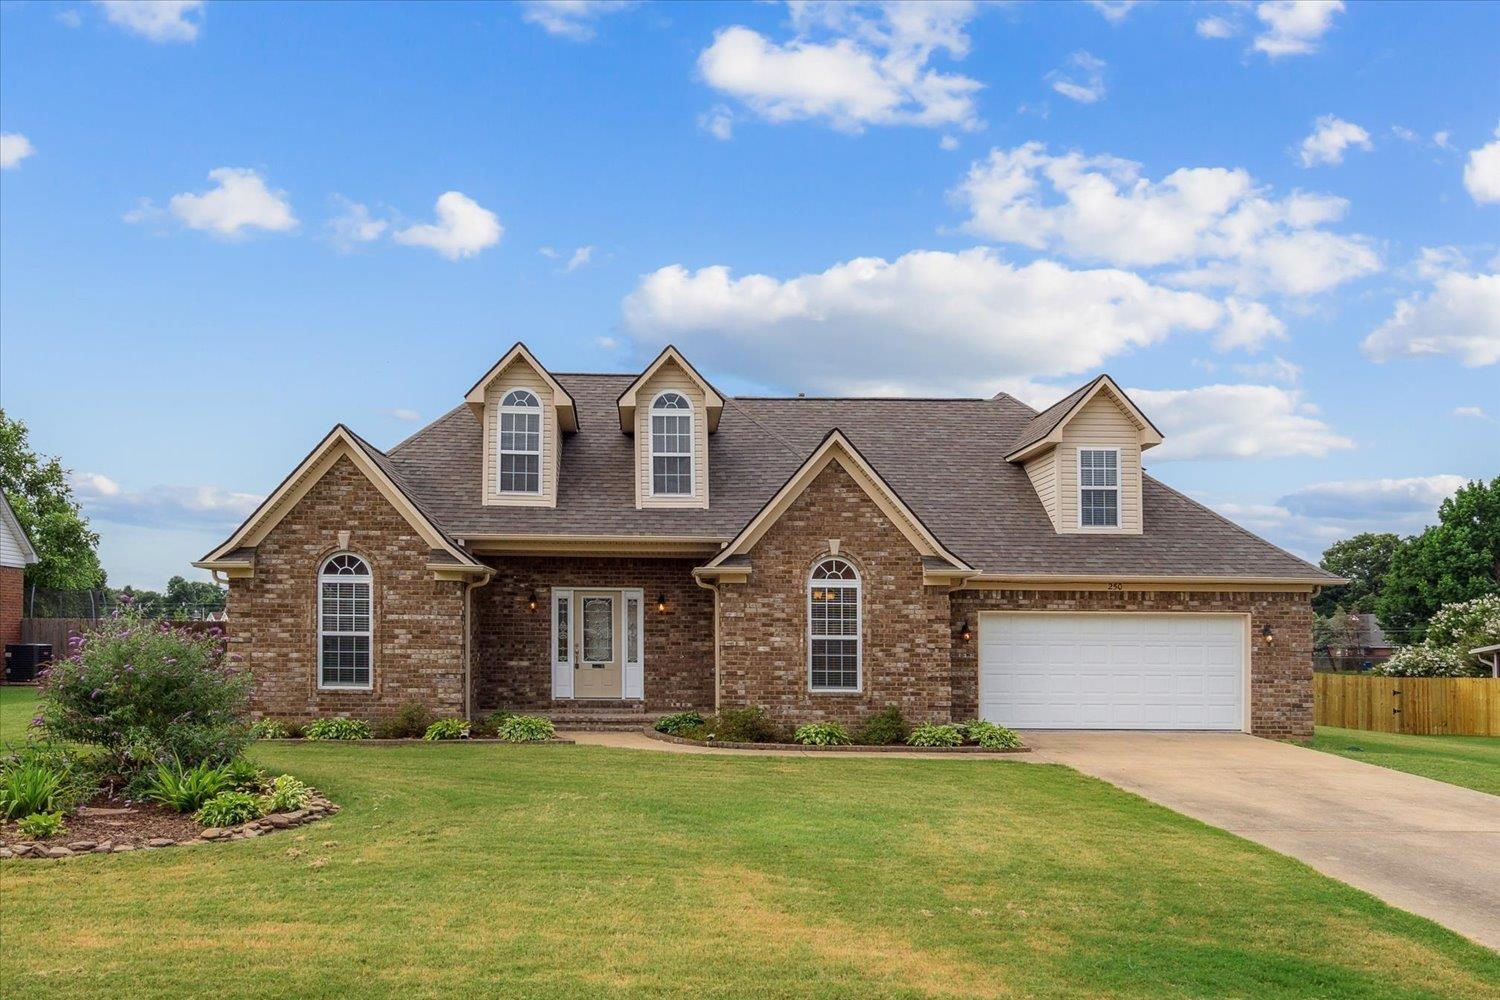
[0,709,1500,997]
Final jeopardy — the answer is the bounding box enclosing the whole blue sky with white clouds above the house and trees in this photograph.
[0,1,1500,586]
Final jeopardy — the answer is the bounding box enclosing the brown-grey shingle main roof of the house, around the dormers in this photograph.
[387,375,1337,582]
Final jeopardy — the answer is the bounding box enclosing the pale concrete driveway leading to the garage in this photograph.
[1025,730,1500,949]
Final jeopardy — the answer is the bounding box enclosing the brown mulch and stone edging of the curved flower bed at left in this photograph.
[0,792,339,859]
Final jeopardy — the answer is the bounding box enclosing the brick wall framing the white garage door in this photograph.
[951,591,1313,739]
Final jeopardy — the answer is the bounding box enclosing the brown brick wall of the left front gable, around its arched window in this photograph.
[228,457,464,720]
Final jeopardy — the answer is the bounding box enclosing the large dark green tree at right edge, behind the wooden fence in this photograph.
[1376,475,1500,643]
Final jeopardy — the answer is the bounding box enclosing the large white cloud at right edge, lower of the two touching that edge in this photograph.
[1361,256,1500,367]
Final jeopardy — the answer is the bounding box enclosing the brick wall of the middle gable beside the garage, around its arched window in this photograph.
[719,463,951,726]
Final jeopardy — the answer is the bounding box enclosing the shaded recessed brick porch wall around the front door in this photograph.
[474,556,714,712]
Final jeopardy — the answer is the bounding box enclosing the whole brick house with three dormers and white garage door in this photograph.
[195,345,1338,736]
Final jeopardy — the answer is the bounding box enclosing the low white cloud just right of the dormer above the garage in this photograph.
[1127,385,1355,462]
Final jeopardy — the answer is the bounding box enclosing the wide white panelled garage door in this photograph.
[980,613,1245,730]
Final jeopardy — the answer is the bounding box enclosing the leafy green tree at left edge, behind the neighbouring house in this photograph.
[0,409,105,591]
